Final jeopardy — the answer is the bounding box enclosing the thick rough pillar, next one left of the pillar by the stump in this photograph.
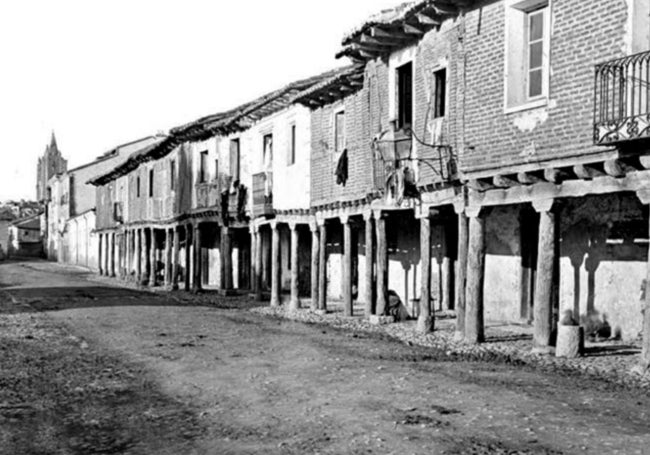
[465,206,485,344]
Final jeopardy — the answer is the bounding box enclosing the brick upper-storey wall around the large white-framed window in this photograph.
[461,0,627,173]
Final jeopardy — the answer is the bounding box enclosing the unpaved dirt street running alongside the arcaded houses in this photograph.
[0,262,650,454]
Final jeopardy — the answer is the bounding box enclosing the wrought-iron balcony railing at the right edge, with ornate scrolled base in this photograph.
[594,52,650,145]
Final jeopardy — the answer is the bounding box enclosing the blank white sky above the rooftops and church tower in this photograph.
[0,0,399,201]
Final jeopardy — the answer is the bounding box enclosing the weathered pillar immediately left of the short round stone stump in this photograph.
[533,199,556,353]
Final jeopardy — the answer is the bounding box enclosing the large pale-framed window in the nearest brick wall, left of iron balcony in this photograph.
[505,0,551,111]
